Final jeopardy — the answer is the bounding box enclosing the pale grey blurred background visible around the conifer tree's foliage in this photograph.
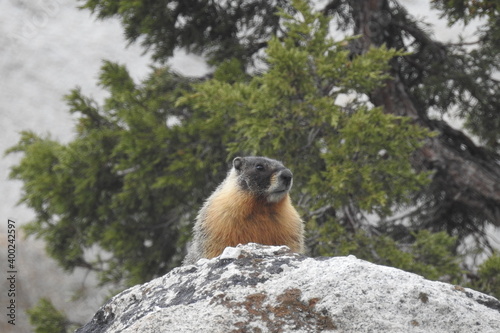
[0,0,488,332]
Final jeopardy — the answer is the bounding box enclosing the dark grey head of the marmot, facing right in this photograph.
[233,156,293,203]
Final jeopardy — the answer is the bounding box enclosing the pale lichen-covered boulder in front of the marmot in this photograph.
[77,244,500,333]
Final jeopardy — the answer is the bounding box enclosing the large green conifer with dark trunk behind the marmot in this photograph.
[9,5,500,332]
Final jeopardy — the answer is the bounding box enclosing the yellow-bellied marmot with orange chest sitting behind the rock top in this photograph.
[183,156,304,265]
